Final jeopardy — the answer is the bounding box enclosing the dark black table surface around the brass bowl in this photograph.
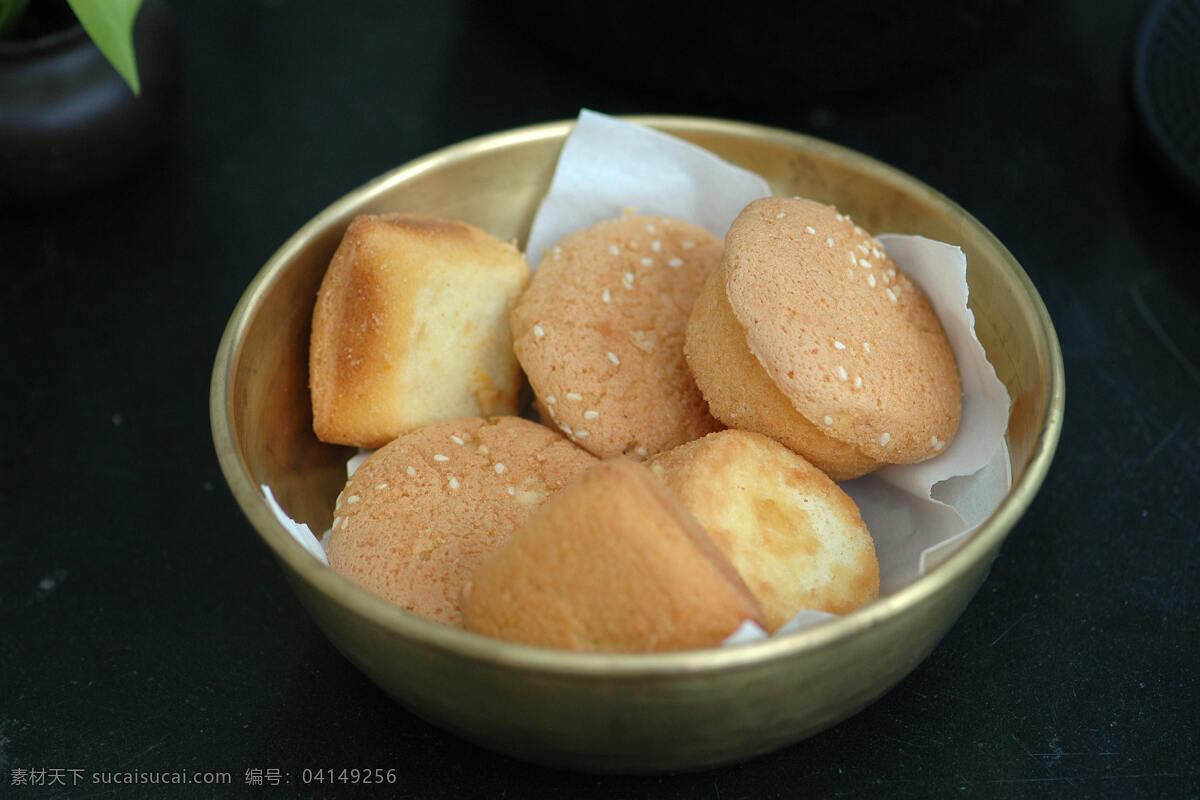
[0,0,1200,799]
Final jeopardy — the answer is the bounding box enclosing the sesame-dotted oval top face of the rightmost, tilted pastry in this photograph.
[724,198,962,463]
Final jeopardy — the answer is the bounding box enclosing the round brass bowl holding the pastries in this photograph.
[210,116,1064,772]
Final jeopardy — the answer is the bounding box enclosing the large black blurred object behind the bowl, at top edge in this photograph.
[497,0,1037,104]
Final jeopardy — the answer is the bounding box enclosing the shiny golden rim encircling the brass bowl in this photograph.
[209,114,1066,679]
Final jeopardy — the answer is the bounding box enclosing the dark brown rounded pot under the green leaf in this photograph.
[0,0,180,207]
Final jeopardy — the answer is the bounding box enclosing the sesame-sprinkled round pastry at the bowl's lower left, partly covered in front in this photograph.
[326,416,595,625]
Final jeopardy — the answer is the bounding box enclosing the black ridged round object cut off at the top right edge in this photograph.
[1133,0,1200,201]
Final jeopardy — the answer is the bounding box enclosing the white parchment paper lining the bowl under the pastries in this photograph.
[264,109,1012,644]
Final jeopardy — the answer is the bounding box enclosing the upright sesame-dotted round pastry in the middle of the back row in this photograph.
[511,215,721,458]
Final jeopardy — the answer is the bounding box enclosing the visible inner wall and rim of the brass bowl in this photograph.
[211,116,1063,762]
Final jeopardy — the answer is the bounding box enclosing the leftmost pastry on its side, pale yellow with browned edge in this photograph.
[308,213,529,449]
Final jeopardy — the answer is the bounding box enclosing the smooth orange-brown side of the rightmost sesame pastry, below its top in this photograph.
[684,270,880,481]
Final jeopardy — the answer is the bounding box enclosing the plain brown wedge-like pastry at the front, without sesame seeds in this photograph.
[453,458,762,652]
